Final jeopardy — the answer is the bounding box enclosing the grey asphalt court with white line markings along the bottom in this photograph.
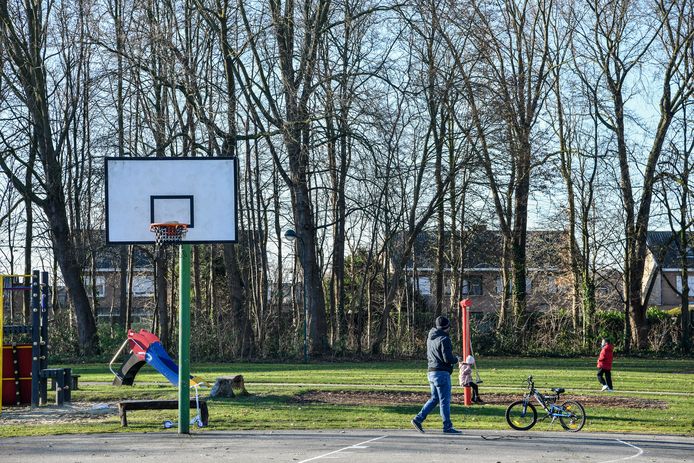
[0,430,694,463]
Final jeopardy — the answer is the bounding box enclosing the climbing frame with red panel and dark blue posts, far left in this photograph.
[0,270,72,416]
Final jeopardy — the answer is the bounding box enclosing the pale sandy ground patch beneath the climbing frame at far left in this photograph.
[0,402,118,424]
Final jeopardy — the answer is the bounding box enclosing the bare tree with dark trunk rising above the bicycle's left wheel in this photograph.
[447,1,554,338]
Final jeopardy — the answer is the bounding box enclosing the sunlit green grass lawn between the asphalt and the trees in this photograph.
[0,357,694,437]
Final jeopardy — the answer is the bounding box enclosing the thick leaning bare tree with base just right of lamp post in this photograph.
[231,0,340,354]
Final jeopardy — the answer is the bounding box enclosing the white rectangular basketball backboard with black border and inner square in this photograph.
[105,157,237,244]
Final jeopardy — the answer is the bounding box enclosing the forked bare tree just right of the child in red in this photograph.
[582,0,694,349]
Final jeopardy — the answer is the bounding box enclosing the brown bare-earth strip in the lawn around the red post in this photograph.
[294,391,667,410]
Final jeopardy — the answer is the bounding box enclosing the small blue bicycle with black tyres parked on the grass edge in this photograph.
[506,376,586,432]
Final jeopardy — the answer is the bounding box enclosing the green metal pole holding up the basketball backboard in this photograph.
[178,244,190,434]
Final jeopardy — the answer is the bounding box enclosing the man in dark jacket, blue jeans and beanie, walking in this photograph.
[412,317,461,434]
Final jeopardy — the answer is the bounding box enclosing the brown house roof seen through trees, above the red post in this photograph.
[407,229,568,270]
